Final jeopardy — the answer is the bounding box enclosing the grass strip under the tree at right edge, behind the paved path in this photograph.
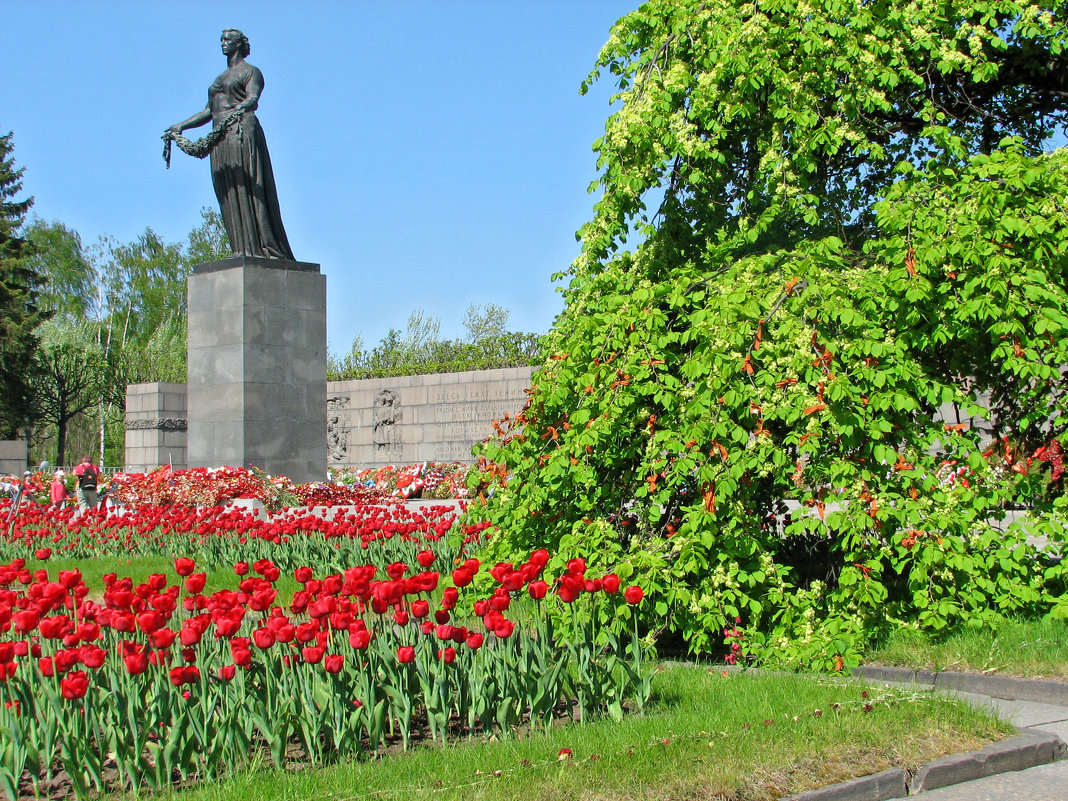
[864,621,1068,681]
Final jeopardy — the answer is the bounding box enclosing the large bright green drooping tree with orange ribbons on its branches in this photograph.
[482,0,1068,670]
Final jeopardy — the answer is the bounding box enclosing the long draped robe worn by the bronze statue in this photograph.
[208,63,295,261]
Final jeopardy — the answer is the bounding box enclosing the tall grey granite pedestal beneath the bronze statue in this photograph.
[187,256,327,483]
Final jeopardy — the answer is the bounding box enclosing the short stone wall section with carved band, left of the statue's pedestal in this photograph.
[125,381,188,473]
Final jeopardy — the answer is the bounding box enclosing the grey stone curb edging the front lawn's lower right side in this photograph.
[784,728,1066,801]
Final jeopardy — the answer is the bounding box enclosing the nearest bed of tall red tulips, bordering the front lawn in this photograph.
[0,549,649,798]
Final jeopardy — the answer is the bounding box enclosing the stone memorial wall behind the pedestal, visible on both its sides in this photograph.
[126,367,533,471]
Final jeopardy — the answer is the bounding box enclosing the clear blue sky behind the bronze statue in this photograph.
[0,0,638,352]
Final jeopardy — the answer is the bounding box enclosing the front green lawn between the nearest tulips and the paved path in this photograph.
[139,666,1012,801]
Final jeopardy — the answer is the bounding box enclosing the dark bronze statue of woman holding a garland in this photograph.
[163,28,295,261]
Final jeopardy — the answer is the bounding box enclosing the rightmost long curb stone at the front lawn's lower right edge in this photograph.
[909,731,1064,795]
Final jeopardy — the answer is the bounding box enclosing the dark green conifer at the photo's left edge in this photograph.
[0,132,44,439]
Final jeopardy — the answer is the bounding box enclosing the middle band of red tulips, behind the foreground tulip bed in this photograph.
[0,500,487,571]
